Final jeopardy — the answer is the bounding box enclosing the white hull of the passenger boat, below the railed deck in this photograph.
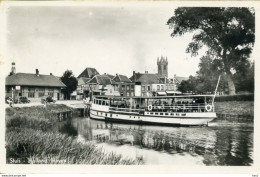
[90,105,216,126]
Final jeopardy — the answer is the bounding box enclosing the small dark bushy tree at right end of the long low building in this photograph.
[61,70,78,100]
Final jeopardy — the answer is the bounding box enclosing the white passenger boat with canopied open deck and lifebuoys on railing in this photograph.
[90,95,216,126]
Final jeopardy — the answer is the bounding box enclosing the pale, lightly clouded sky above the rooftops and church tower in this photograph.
[6,4,256,77]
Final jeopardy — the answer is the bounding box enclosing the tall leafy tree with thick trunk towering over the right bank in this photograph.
[167,7,255,94]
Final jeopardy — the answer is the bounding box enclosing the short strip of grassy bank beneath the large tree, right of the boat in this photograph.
[215,101,254,116]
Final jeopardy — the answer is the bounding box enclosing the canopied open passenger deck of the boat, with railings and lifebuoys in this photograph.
[93,95,214,112]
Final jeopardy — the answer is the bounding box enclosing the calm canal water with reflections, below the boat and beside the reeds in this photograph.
[60,118,254,166]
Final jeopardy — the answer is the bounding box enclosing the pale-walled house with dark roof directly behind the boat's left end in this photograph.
[87,74,120,96]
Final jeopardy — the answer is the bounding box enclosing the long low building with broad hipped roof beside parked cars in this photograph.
[5,63,66,102]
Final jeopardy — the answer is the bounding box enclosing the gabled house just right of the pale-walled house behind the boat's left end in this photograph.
[113,74,135,97]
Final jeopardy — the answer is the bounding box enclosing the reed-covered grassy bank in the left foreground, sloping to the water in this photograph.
[6,105,141,165]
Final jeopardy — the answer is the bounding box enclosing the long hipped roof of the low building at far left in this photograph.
[5,73,66,87]
